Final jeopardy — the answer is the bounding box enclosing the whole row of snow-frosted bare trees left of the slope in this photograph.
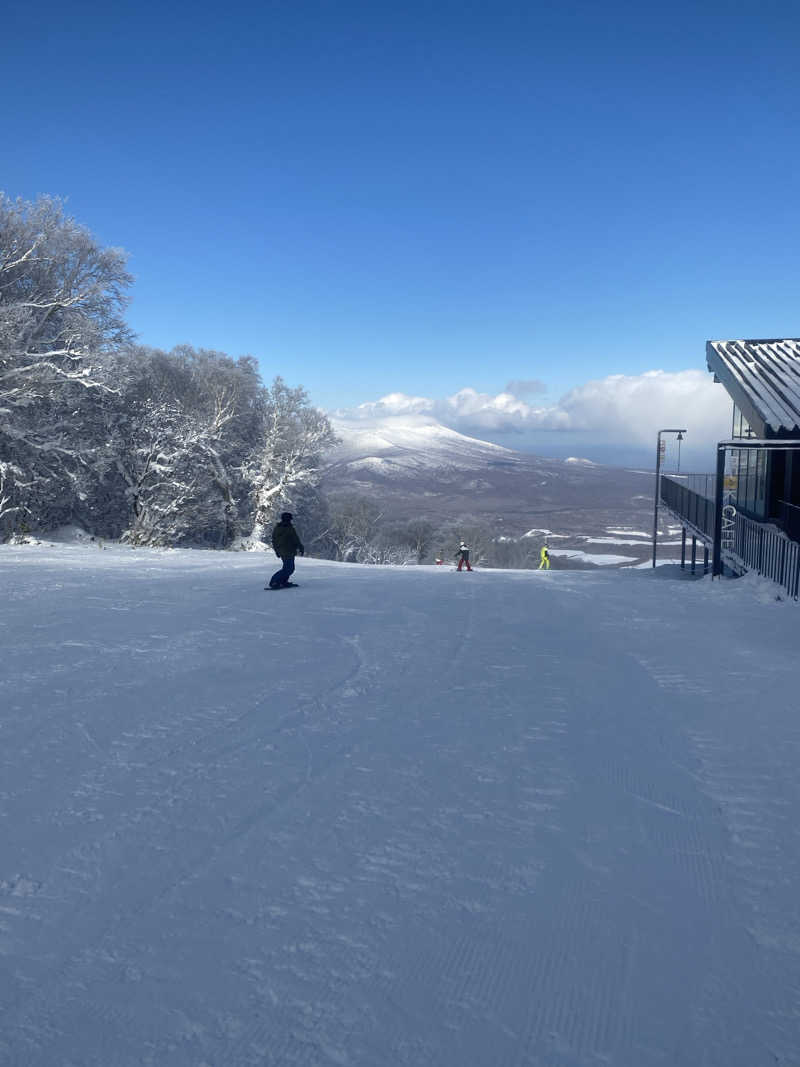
[0,194,335,555]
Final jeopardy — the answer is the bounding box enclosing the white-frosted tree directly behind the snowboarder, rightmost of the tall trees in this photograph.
[246,377,336,541]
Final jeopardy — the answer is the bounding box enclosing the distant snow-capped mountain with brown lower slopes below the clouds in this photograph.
[322,415,669,562]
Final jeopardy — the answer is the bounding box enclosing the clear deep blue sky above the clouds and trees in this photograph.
[6,0,800,463]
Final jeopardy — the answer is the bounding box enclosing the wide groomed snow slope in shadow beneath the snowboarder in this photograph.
[0,545,800,1067]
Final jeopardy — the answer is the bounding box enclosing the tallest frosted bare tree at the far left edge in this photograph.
[0,194,131,530]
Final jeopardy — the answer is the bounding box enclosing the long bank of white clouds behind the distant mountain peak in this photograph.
[335,370,731,447]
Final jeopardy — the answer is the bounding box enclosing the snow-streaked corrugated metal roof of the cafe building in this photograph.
[706,337,800,433]
